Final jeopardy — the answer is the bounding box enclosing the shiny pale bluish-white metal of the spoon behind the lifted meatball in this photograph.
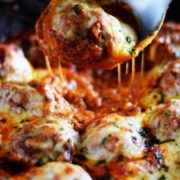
[119,0,172,40]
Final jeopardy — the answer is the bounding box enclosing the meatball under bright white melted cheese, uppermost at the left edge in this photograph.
[0,44,33,82]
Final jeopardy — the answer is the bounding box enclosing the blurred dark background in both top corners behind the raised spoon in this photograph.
[0,0,180,42]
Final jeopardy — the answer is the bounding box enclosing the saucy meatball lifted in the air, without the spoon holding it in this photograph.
[36,0,137,69]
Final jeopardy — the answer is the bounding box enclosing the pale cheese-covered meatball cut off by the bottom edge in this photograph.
[11,162,91,180]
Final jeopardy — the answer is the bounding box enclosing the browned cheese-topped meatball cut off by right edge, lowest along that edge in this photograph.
[148,100,180,141]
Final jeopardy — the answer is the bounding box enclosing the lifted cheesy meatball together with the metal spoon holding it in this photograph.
[36,0,171,69]
